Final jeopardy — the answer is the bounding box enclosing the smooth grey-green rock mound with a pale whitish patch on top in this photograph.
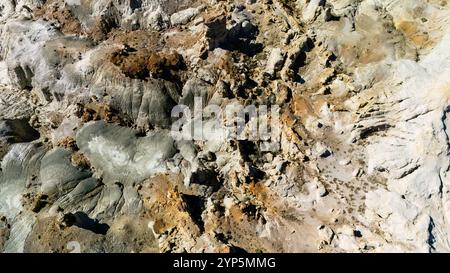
[76,121,175,185]
